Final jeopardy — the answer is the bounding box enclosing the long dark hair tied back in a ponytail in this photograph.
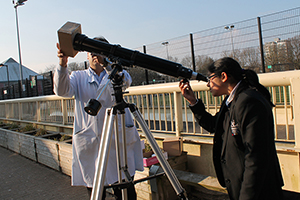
[208,57,274,106]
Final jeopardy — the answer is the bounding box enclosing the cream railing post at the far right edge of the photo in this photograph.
[290,77,300,149]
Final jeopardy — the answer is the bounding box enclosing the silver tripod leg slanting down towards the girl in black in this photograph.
[130,105,187,199]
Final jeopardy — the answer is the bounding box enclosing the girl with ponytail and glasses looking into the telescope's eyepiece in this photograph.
[179,57,283,200]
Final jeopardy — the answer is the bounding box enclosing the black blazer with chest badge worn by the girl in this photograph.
[190,82,283,200]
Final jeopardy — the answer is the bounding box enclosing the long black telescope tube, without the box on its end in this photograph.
[73,33,207,82]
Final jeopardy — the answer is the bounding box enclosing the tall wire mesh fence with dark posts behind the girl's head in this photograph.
[136,7,300,73]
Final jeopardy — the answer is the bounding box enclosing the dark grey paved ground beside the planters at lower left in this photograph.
[0,147,113,200]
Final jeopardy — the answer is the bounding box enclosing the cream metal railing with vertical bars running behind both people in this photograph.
[0,70,300,148]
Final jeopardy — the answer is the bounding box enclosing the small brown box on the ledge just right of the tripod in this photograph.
[163,137,183,156]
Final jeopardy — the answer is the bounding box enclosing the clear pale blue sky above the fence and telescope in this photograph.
[0,0,300,73]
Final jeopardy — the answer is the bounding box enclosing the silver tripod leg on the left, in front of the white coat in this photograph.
[91,109,115,200]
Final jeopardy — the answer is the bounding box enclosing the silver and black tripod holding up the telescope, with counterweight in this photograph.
[85,63,187,200]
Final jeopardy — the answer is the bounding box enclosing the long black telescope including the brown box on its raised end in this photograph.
[58,22,207,82]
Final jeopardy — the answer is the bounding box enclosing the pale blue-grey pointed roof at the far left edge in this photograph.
[0,58,38,82]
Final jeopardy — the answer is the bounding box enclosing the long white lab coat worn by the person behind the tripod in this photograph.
[54,66,144,187]
